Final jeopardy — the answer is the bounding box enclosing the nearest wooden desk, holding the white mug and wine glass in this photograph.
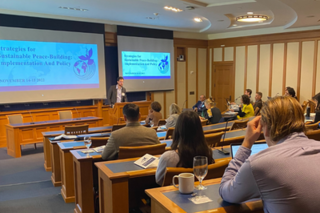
[146,178,263,213]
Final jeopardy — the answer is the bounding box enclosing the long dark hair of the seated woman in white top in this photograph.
[171,111,214,168]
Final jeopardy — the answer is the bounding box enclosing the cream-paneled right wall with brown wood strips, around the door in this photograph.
[208,30,320,103]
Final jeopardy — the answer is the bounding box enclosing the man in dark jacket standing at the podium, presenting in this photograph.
[108,77,128,107]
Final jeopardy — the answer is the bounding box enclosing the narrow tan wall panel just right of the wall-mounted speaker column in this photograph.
[187,48,198,107]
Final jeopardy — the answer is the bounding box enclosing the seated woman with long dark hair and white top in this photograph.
[156,111,214,186]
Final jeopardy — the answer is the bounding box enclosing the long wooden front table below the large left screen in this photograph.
[6,117,102,158]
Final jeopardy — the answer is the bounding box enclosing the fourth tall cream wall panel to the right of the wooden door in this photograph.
[271,43,284,97]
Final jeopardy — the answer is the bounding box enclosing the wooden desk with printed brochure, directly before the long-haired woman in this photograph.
[95,150,230,213]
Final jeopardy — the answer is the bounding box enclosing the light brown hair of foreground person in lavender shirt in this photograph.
[260,96,305,142]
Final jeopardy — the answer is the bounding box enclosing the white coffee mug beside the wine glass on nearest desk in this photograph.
[172,173,194,194]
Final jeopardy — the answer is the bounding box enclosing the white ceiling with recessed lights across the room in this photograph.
[0,0,320,34]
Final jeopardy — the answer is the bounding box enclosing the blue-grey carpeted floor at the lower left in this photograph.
[0,144,75,213]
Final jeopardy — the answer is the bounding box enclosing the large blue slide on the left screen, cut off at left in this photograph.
[0,40,99,92]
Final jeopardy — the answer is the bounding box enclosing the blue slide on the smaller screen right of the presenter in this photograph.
[122,51,171,79]
